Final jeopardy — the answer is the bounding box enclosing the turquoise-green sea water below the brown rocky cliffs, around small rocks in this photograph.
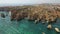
[0,12,60,34]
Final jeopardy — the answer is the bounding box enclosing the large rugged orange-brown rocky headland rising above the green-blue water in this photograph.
[11,6,60,22]
